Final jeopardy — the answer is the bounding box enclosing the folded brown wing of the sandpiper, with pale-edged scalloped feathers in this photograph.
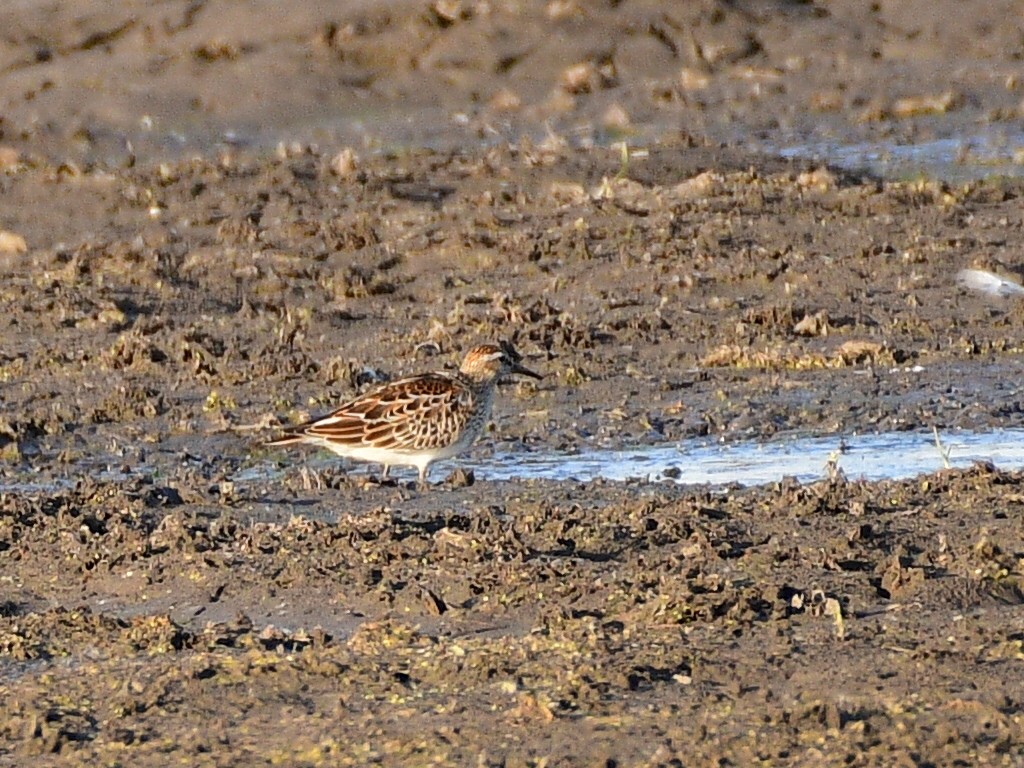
[301,374,473,451]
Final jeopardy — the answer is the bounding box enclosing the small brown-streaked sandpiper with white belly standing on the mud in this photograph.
[266,343,542,485]
